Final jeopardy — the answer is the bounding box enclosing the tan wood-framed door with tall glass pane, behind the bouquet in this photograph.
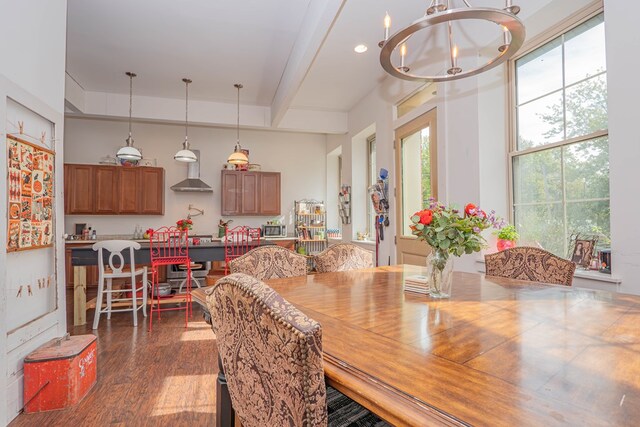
[395,108,438,266]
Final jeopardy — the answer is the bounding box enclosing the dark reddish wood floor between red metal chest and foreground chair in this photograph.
[10,290,218,427]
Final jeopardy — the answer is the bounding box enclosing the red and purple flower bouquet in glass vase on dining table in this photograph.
[409,199,503,298]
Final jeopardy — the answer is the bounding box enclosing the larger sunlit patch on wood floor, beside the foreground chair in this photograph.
[151,374,217,417]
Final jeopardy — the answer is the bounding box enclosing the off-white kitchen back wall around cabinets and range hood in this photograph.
[64,117,327,234]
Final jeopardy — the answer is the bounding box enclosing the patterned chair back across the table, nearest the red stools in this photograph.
[229,245,307,280]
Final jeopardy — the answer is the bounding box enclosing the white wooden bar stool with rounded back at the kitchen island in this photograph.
[92,240,147,329]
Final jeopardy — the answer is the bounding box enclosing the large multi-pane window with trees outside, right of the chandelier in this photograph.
[510,14,610,256]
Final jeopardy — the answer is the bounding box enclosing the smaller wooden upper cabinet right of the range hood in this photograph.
[220,171,280,216]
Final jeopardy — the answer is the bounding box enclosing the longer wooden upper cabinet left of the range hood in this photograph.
[64,164,164,215]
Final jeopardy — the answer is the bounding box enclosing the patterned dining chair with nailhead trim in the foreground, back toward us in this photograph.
[207,273,388,427]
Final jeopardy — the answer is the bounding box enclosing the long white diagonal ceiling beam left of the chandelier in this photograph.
[271,0,346,127]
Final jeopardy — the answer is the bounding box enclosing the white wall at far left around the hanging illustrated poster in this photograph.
[0,0,67,425]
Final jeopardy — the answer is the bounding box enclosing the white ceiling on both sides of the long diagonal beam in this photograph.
[67,0,551,118]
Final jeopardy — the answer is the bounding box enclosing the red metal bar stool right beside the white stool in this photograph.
[149,227,193,331]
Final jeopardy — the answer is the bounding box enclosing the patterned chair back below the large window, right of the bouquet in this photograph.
[484,246,576,286]
